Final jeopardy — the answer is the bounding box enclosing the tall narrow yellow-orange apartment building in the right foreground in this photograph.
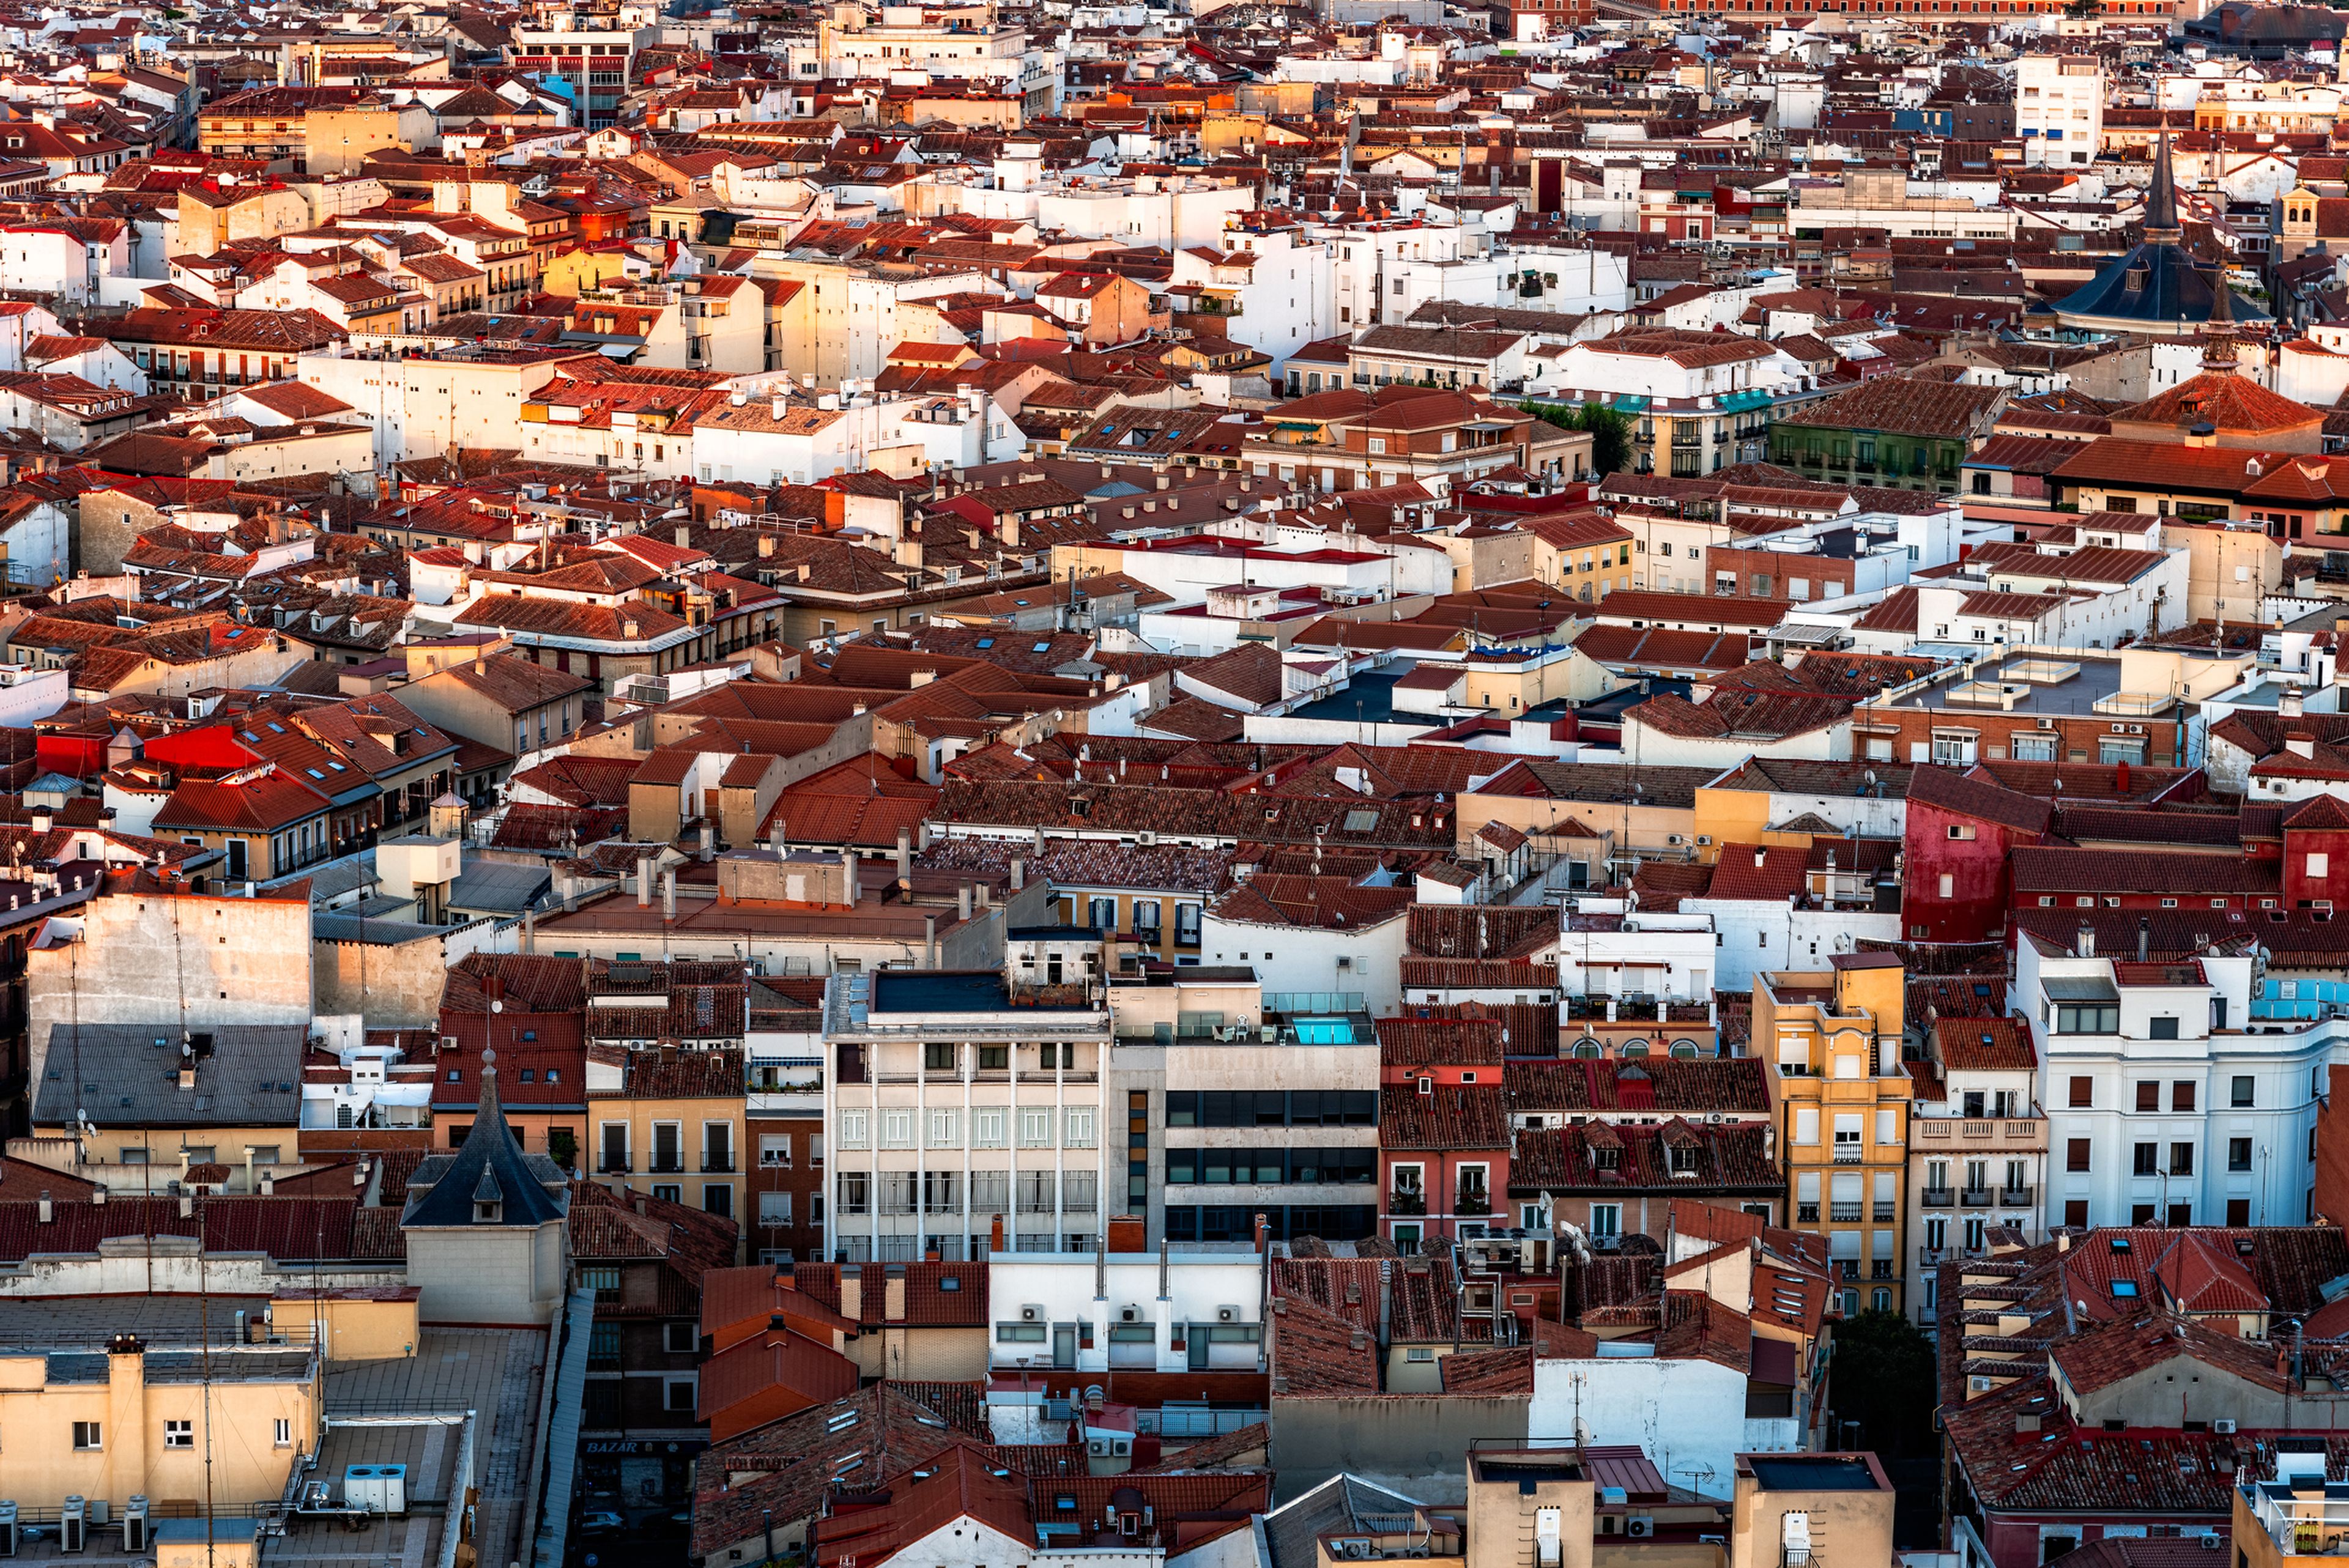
[1753,953,1915,1317]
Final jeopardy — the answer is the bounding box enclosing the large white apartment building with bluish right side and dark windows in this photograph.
[2013,918,2340,1226]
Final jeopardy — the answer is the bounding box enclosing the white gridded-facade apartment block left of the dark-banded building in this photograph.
[825,969,1111,1263]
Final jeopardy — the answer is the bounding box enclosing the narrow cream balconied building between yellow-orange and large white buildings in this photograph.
[1902,1016,2048,1331]
